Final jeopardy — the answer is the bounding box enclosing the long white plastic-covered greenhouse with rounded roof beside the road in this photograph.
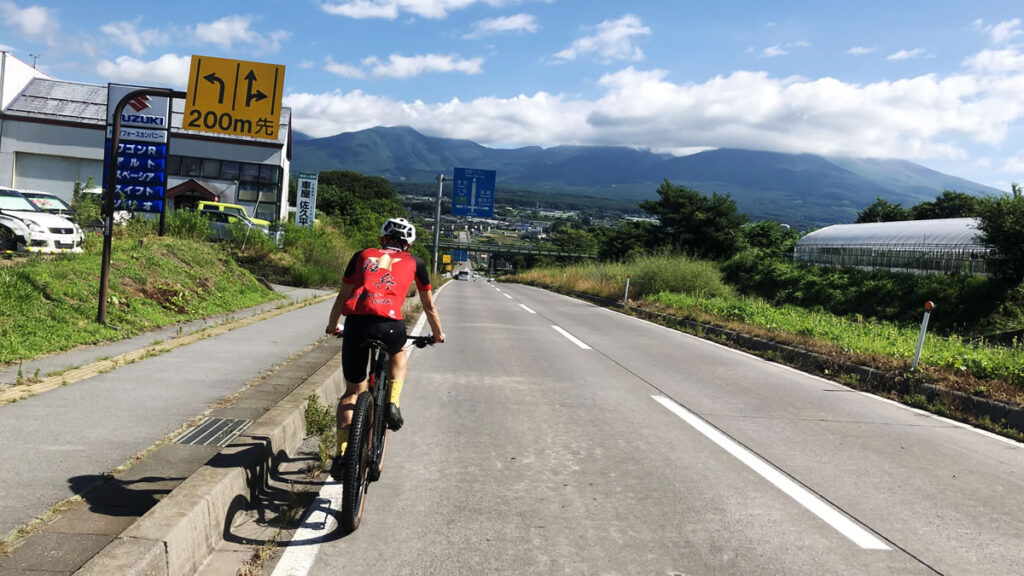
[793,218,990,274]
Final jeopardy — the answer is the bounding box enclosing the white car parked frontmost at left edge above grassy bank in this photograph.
[0,188,85,253]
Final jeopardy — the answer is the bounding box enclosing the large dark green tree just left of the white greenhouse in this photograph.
[640,179,746,259]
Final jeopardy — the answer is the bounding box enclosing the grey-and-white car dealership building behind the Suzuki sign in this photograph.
[0,52,292,221]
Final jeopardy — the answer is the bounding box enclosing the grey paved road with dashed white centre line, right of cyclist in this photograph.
[273,281,1024,576]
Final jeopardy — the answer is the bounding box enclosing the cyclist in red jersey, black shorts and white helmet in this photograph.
[327,218,444,457]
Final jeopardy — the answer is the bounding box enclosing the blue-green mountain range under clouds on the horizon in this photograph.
[292,126,1002,230]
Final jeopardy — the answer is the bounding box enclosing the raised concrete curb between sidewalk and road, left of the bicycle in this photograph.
[76,355,345,576]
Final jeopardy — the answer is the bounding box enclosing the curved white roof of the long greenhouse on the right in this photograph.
[797,218,983,246]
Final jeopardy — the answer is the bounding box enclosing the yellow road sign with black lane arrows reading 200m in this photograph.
[181,55,285,139]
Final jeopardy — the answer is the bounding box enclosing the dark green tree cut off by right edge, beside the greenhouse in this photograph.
[978,182,1024,285]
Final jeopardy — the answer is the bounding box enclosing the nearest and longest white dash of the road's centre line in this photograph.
[651,396,891,550]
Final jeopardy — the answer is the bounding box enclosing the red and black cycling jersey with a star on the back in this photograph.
[341,248,430,320]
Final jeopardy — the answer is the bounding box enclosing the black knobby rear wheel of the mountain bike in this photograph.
[341,392,374,534]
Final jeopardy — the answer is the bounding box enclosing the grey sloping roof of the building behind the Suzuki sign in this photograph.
[3,78,292,146]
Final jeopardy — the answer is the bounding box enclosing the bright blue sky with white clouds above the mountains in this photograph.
[0,0,1024,191]
